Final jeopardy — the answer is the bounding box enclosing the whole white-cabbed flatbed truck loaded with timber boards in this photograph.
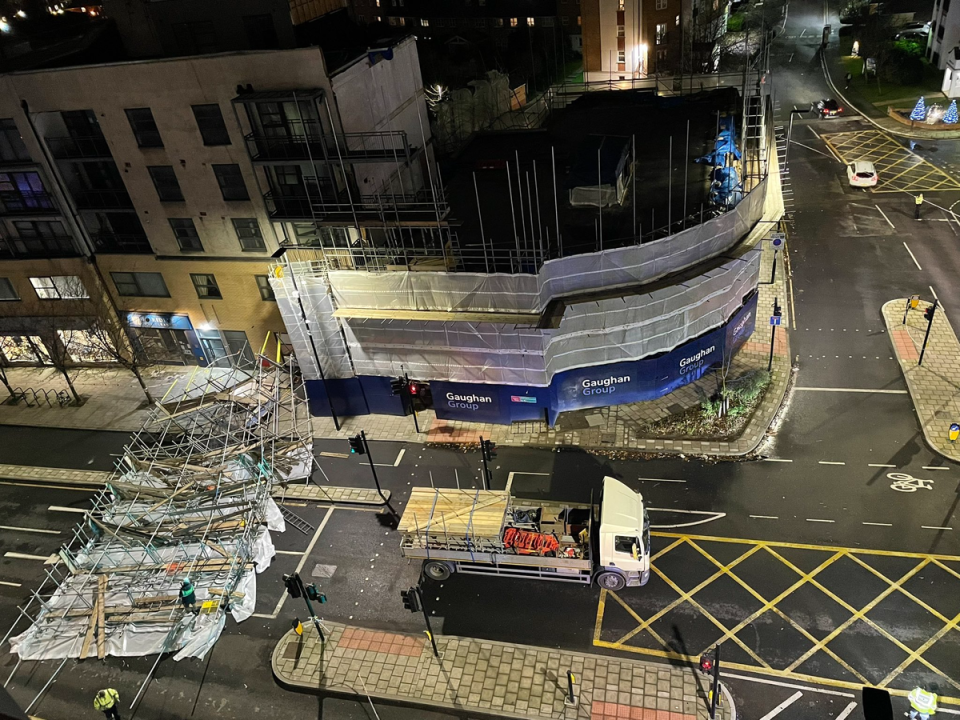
[398,477,650,590]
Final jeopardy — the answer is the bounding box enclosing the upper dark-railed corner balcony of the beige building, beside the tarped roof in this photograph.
[245,131,417,162]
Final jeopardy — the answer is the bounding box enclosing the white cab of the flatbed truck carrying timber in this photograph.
[596,476,650,590]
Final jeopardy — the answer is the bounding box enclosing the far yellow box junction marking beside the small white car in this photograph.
[821,130,960,193]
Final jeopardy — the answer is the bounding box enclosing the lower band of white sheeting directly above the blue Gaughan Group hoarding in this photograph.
[344,250,760,386]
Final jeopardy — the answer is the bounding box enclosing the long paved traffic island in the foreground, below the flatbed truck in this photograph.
[272,623,735,720]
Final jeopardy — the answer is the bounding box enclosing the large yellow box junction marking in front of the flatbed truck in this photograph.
[593,532,960,705]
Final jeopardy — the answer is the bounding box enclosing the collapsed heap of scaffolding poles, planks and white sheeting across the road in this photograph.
[4,356,313,709]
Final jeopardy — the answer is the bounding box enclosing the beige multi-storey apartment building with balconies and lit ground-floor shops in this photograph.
[0,38,434,365]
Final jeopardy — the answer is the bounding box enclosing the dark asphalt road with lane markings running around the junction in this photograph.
[0,0,960,720]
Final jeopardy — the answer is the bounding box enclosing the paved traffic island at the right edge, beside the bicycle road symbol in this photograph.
[883,298,960,462]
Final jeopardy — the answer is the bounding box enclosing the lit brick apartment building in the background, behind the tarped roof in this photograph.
[581,0,729,82]
